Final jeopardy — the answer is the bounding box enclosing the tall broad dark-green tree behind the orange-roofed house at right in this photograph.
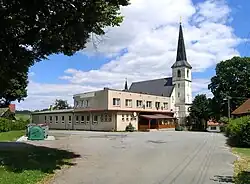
[208,57,250,116]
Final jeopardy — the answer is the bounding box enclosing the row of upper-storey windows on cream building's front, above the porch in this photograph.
[113,98,168,109]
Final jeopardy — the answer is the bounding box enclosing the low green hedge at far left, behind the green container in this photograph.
[0,118,29,132]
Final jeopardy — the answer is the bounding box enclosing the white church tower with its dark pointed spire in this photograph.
[171,23,192,124]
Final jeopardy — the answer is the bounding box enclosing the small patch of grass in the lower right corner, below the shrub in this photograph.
[233,148,250,184]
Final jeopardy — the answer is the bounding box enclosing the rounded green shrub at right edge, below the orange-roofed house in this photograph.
[226,116,250,147]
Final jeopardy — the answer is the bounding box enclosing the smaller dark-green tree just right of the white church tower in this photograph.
[189,94,210,130]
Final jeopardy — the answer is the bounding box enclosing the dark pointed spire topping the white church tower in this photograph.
[172,22,192,69]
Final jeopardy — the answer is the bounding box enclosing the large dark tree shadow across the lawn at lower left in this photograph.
[0,142,80,173]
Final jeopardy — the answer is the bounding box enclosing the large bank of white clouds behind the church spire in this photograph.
[17,0,243,107]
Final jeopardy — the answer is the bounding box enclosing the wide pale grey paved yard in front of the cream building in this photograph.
[36,131,236,184]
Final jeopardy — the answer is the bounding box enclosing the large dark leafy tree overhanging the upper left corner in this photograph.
[0,0,129,106]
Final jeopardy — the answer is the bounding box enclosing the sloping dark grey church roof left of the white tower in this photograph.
[129,77,174,97]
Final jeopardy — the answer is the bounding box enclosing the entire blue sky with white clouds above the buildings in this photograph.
[16,0,250,110]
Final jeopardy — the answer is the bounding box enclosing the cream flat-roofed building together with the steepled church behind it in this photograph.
[32,23,192,131]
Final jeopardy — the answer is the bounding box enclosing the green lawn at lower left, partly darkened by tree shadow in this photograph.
[0,131,79,184]
